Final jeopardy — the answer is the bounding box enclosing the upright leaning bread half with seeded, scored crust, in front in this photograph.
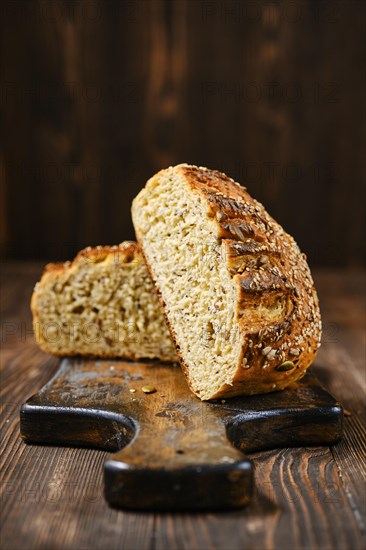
[132,164,321,400]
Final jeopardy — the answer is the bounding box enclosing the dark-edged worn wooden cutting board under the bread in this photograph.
[20,359,343,511]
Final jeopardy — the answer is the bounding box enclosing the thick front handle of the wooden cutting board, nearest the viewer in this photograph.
[104,411,253,510]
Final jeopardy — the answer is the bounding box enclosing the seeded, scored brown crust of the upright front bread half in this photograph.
[135,164,321,399]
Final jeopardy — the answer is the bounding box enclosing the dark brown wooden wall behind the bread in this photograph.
[0,0,365,265]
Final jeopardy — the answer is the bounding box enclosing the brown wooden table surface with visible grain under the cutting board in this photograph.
[1,263,366,550]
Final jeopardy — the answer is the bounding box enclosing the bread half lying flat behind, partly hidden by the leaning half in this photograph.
[31,242,178,361]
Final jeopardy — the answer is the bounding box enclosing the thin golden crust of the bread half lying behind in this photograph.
[31,241,177,362]
